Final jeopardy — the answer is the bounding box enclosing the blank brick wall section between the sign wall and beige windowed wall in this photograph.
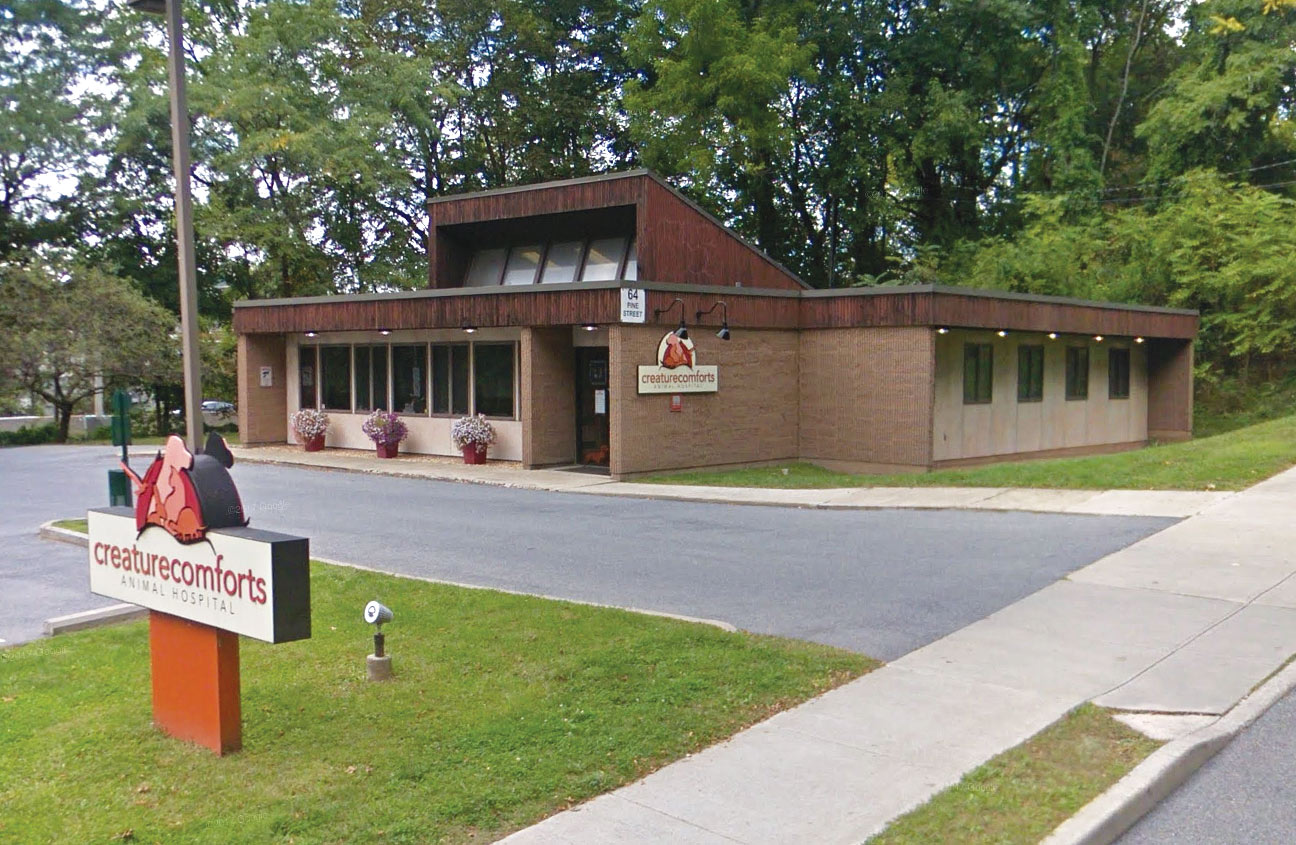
[800,328,934,468]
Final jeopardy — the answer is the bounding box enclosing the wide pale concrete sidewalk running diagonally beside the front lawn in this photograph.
[505,469,1296,845]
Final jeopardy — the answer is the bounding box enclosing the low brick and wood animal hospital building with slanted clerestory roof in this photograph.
[233,171,1198,478]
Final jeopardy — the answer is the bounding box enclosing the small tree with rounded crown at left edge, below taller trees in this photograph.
[0,262,179,442]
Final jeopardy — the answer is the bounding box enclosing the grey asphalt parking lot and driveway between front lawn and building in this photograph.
[0,446,1173,660]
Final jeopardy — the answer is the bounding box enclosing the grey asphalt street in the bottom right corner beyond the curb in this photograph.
[1120,693,1296,845]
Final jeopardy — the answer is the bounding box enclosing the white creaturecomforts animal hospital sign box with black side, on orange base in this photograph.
[87,508,311,643]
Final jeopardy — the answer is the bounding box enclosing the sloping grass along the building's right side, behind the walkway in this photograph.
[642,416,1296,490]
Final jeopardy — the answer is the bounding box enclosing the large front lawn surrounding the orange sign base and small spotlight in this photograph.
[0,562,875,844]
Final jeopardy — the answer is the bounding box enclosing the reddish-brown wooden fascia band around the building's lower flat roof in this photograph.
[235,281,1198,340]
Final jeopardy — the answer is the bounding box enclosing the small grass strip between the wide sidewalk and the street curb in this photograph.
[868,704,1161,845]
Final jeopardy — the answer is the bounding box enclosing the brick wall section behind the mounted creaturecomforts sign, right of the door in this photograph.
[608,325,798,476]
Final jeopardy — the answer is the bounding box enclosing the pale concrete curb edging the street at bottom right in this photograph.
[1043,664,1296,845]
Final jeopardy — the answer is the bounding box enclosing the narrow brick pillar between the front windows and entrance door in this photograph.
[521,327,575,469]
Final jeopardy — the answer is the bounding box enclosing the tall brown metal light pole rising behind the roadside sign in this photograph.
[127,0,202,454]
